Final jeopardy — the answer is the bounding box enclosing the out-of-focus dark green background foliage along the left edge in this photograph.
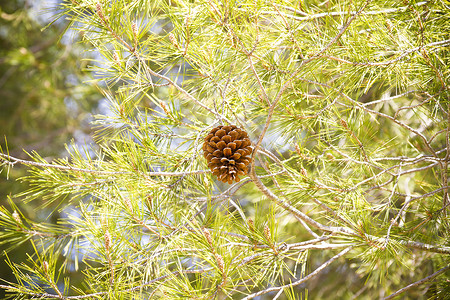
[0,0,100,299]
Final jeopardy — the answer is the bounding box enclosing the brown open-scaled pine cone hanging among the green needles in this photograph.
[203,125,252,184]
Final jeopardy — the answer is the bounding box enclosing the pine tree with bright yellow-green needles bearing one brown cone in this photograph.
[0,0,450,299]
